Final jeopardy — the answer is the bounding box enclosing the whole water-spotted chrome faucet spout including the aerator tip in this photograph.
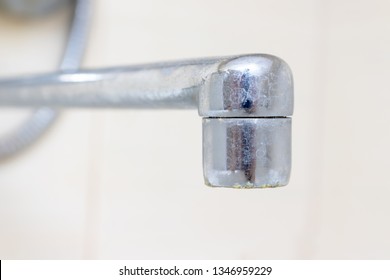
[0,54,293,188]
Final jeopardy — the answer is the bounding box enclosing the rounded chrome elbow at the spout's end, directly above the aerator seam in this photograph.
[199,55,294,117]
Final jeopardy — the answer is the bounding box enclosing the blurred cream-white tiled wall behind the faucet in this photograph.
[0,0,390,259]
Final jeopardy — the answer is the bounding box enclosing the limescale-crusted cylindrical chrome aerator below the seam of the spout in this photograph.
[203,118,291,188]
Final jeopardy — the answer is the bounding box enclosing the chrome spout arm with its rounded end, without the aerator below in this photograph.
[0,55,293,112]
